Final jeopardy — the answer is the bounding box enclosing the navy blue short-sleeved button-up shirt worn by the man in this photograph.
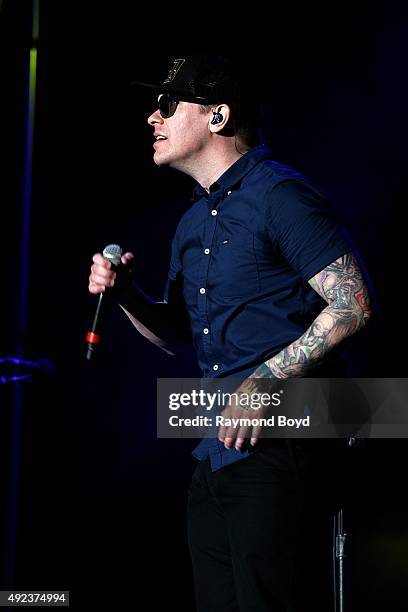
[165,145,352,469]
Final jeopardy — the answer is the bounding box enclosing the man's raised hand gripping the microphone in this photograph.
[88,253,134,294]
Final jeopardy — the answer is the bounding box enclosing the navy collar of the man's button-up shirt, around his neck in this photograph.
[193,144,271,200]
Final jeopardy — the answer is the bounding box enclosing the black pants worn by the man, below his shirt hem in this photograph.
[187,440,310,612]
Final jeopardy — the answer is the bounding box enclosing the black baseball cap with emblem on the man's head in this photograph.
[131,55,257,111]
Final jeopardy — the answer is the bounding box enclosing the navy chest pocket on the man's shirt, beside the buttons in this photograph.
[209,228,260,300]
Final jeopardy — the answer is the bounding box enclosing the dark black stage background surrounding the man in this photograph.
[0,0,408,610]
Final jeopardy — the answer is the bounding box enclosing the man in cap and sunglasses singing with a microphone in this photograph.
[89,56,370,612]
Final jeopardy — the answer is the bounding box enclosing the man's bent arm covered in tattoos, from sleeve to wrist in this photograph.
[251,252,371,378]
